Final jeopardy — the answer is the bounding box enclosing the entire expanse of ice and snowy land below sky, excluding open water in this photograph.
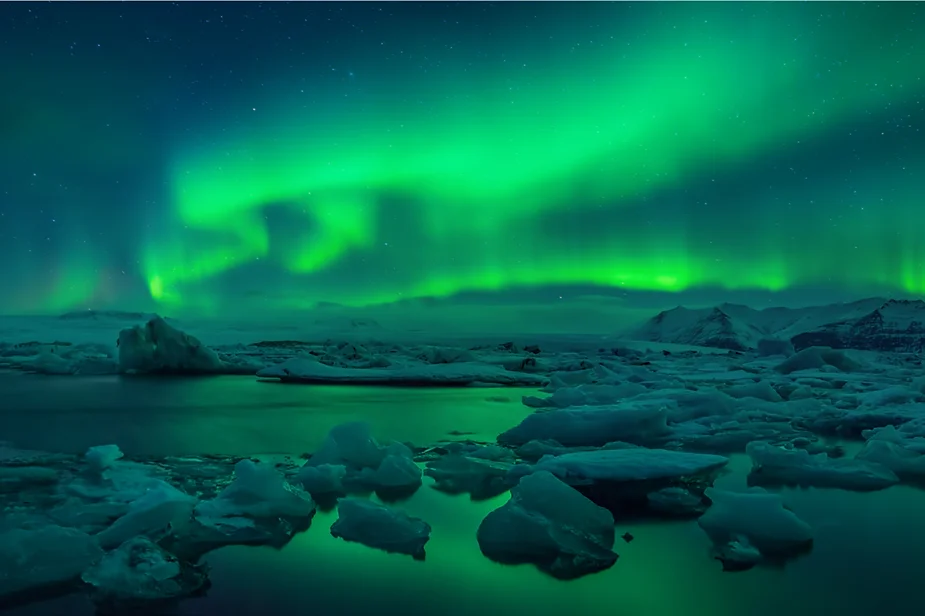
[0,299,925,612]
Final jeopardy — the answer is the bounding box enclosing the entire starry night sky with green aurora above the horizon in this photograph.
[0,2,925,314]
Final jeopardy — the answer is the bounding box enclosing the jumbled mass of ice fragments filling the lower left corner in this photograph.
[0,445,315,613]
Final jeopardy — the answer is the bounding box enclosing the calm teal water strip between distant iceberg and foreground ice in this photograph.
[0,374,536,455]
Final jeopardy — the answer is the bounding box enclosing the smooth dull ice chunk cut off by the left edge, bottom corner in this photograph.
[0,526,103,598]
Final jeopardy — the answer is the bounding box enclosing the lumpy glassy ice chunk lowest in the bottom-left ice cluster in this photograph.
[81,537,206,611]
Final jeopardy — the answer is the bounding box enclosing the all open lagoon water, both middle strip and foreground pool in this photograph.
[0,374,925,616]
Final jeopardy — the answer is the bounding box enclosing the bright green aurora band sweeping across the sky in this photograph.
[142,5,925,307]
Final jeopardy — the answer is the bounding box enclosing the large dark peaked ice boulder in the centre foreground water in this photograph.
[477,472,617,579]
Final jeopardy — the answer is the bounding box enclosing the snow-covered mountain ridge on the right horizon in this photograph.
[632,297,925,353]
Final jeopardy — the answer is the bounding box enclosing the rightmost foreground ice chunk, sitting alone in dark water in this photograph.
[697,488,813,557]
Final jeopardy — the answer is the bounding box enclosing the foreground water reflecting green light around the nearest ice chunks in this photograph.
[191,457,925,616]
